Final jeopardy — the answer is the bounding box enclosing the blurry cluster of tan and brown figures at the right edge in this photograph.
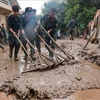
[84,9,100,47]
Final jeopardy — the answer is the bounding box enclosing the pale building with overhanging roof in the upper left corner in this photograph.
[0,0,21,28]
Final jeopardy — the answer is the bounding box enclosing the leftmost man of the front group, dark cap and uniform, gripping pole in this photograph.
[8,5,20,61]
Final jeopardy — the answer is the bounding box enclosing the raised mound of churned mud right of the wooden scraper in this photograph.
[58,40,100,66]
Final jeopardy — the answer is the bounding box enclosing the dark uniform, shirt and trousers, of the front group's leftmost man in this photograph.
[8,15,20,58]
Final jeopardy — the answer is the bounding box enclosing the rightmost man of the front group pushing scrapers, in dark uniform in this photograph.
[40,8,58,60]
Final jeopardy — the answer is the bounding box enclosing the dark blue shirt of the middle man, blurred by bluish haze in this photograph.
[20,14,37,38]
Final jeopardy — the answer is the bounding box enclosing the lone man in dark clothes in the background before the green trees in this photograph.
[68,17,77,40]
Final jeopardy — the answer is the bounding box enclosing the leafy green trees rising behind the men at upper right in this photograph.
[42,0,100,29]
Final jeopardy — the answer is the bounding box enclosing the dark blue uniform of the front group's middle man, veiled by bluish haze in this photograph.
[20,13,37,56]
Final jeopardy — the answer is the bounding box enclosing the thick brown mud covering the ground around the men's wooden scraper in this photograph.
[0,39,100,100]
